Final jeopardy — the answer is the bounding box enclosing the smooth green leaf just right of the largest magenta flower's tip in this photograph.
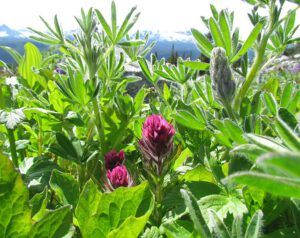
[175,110,205,130]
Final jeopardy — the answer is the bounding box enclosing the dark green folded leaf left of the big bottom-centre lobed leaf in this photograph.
[49,169,79,208]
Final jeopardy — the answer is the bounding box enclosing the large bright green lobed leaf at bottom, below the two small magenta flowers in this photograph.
[75,180,152,238]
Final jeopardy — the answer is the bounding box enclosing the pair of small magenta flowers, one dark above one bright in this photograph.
[104,150,132,189]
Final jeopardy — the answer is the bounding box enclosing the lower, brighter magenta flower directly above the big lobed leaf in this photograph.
[106,165,130,188]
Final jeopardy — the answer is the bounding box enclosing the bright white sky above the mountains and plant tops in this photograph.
[0,0,300,37]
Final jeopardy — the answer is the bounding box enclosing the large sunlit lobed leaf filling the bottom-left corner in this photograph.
[0,154,72,238]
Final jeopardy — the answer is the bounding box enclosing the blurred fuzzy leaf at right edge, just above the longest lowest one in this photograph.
[257,152,300,178]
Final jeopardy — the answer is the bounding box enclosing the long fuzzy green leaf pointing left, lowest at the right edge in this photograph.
[224,172,300,198]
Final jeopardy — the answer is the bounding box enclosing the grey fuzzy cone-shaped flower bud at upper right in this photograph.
[210,47,236,105]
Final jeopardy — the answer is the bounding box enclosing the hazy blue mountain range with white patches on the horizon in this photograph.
[0,25,199,64]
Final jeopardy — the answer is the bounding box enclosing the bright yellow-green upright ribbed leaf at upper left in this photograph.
[18,43,45,88]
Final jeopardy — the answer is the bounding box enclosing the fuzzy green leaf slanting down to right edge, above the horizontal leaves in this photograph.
[275,118,300,151]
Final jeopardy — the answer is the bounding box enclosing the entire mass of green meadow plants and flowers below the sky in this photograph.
[0,0,300,238]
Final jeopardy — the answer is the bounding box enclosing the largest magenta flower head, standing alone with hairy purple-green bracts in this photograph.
[139,115,175,175]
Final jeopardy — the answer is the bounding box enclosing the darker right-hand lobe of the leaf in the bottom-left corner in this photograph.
[29,206,72,238]
